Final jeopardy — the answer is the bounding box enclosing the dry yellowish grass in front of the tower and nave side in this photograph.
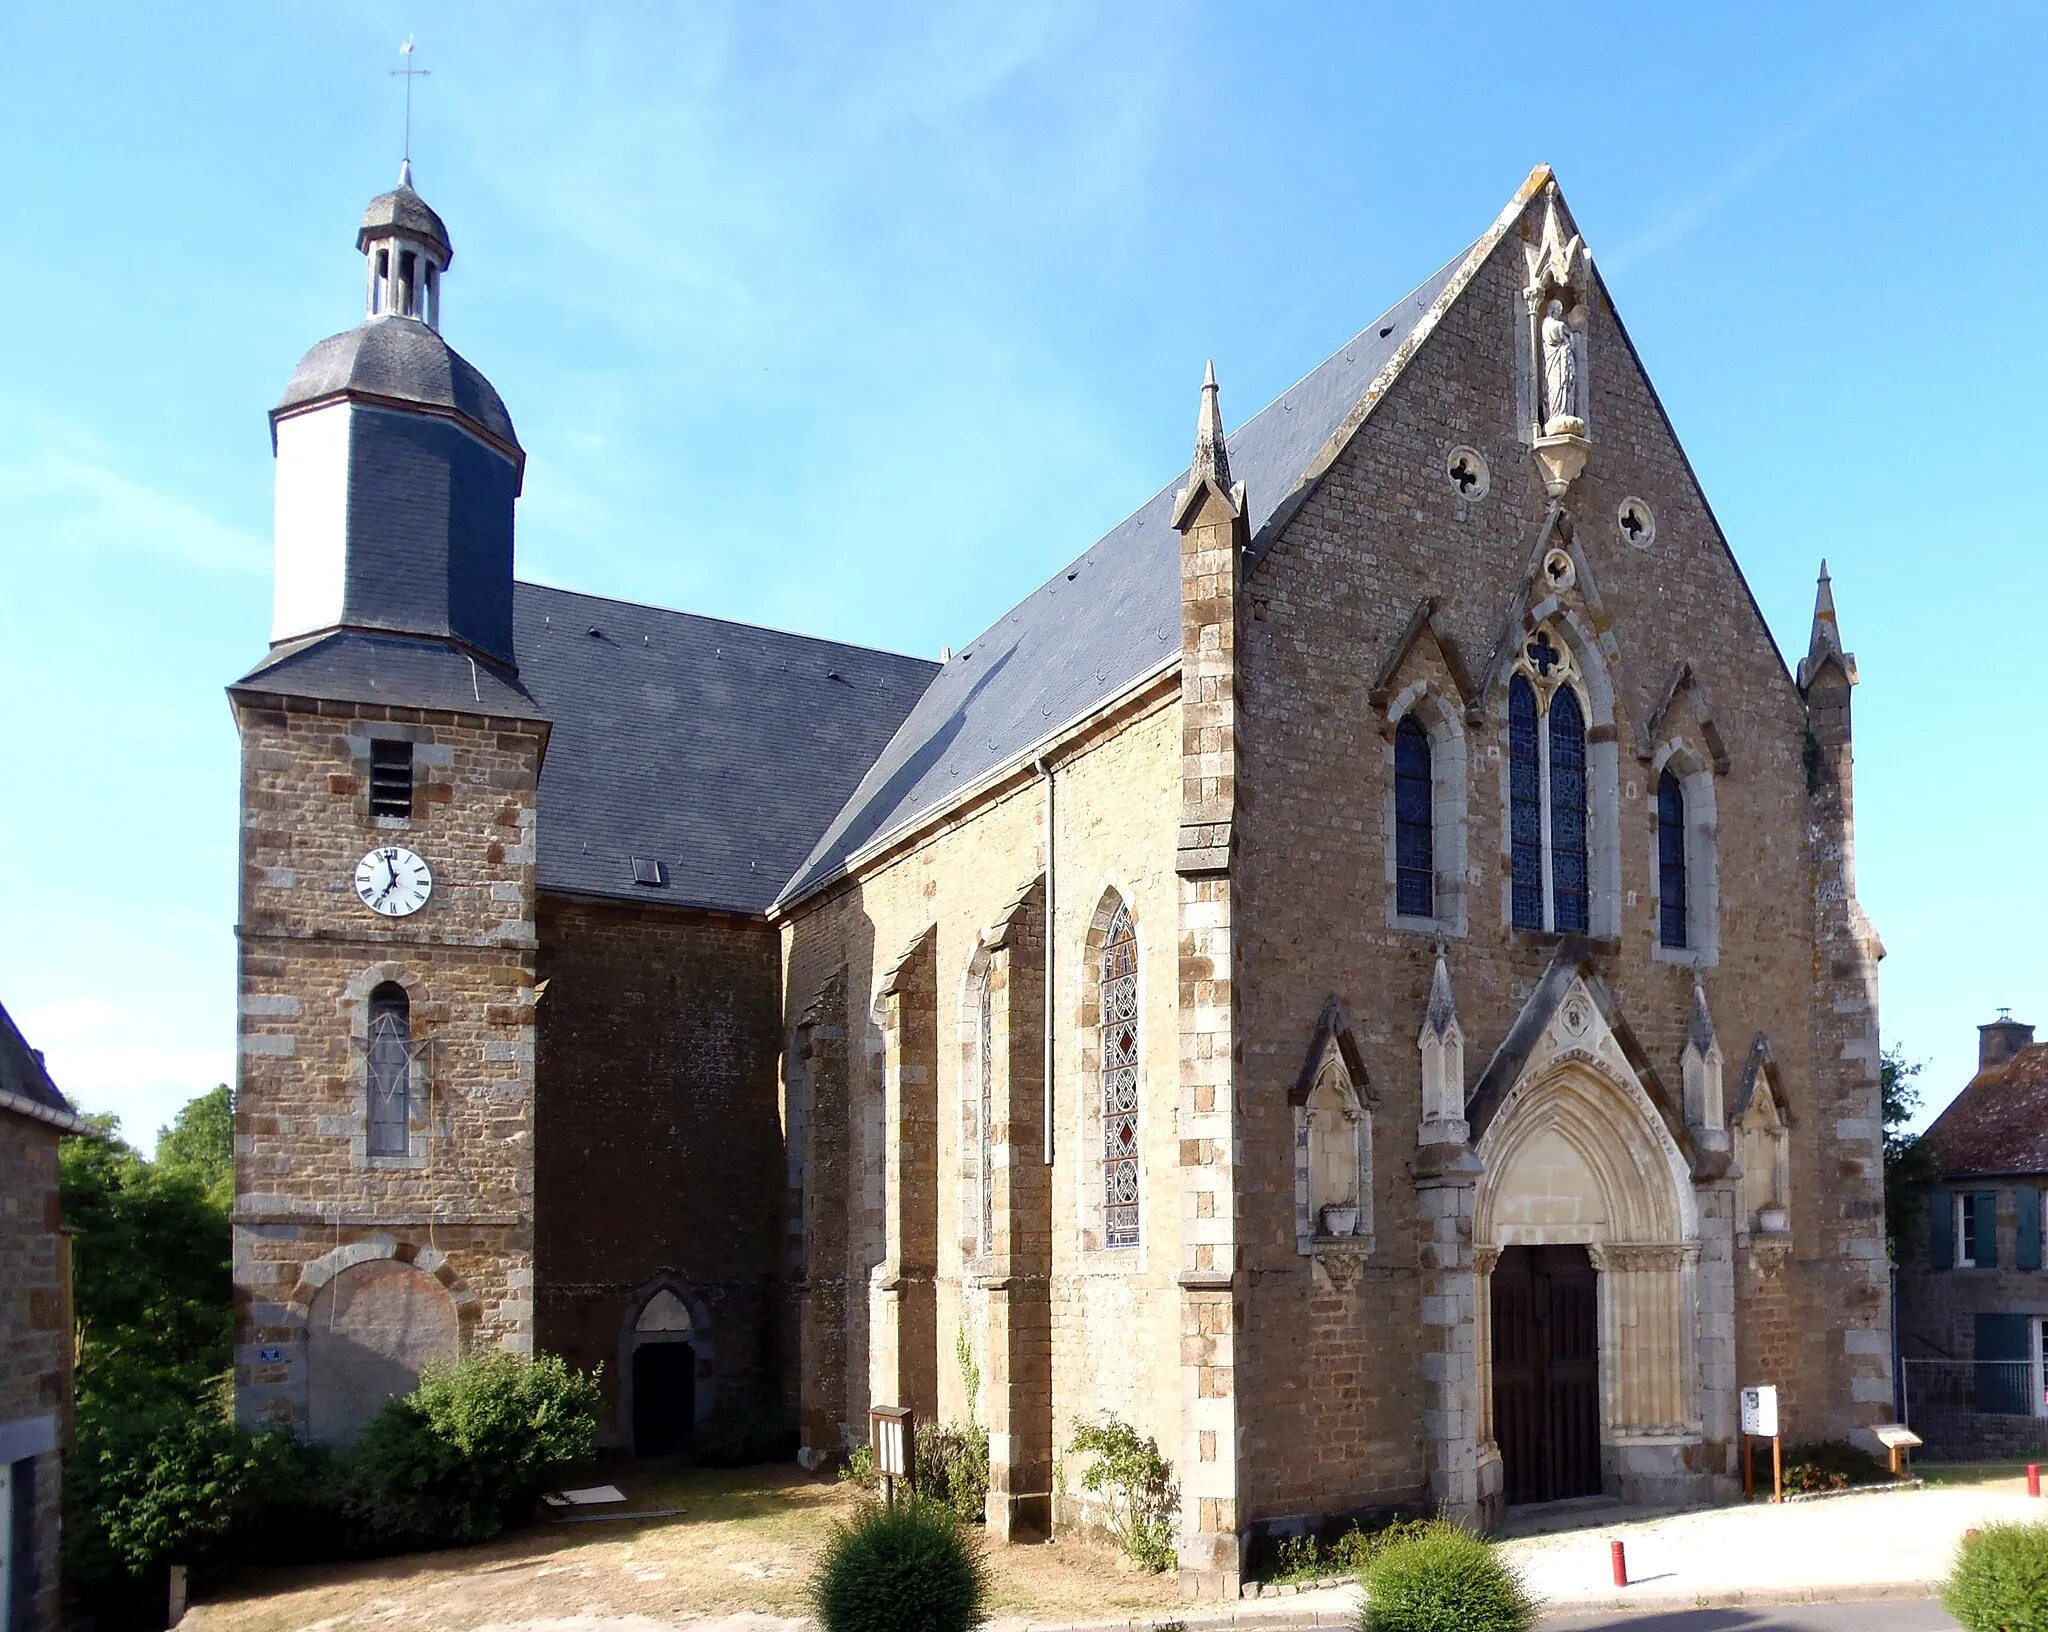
[184,1464,1180,1632]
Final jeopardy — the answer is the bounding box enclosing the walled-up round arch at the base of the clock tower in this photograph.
[305,1259,457,1446]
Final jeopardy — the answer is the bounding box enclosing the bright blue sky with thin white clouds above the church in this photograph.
[0,0,2048,1134]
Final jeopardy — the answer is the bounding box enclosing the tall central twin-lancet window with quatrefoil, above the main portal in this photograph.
[1507,629,1591,934]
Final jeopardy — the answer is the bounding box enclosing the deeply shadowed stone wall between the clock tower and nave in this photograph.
[535,895,784,1444]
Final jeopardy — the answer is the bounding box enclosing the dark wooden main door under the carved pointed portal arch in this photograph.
[1491,1247,1599,1505]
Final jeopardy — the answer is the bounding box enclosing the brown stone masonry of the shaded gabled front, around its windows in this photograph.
[1237,194,1876,1519]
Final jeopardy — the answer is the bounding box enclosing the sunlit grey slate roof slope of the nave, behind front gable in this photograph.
[778,244,1491,905]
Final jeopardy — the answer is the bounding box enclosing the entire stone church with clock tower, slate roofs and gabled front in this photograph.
[231,170,1892,1593]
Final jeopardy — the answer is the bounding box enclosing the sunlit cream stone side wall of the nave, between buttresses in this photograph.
[782,682,1182,1474]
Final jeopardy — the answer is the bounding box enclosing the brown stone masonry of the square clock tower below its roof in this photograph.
[236,696,543,1431]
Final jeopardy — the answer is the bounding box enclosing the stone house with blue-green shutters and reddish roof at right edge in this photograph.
[1898,1010,2048,1456]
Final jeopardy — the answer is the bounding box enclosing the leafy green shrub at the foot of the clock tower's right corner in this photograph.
[346,1351,598,1548]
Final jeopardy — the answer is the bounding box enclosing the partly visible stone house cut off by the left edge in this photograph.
[0,1007,90,1632]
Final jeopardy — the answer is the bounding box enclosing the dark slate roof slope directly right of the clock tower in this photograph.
[514,584,938,913]
